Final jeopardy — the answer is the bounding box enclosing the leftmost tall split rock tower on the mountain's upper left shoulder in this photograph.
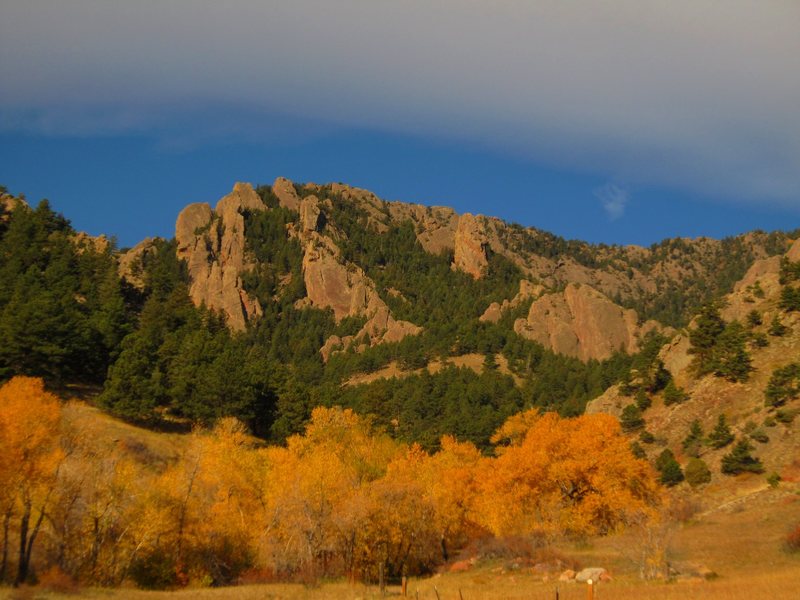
[175,183,266,331]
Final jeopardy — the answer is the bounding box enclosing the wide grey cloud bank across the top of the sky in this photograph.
[0,0,800,206]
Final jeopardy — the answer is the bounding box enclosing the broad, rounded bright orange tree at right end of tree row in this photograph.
[474,411,661,536]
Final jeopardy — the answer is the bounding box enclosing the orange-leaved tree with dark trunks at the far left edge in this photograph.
[0,377,64,585]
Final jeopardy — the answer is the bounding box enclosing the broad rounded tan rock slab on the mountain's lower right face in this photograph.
[514,284,657,360]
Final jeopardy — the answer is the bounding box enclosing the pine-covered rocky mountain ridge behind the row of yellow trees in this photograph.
[0,179,796,449]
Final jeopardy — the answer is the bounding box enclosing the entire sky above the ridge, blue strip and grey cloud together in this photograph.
[0,0,800,246]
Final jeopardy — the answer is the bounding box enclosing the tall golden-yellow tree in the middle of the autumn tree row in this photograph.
[268,407,398,579]
